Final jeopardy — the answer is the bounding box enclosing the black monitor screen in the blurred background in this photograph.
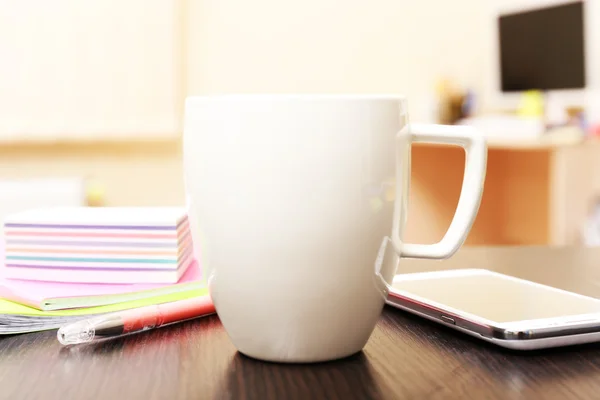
[498,2,585,92]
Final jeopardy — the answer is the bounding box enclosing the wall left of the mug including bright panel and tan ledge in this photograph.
[0,0,185,209]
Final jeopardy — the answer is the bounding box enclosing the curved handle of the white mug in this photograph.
[391,124,487,259]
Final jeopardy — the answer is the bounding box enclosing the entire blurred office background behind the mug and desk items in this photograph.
[0,0,600,246]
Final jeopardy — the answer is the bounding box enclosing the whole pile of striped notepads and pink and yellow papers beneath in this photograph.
[0,207,214,335]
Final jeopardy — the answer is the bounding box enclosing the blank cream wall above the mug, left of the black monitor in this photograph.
[187,0,486,120]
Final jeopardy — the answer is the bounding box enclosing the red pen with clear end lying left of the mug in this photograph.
[57,296,215,345]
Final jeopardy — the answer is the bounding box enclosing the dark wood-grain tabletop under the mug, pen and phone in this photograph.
[0,247,600,400]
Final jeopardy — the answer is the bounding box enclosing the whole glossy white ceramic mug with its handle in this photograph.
[183,95,487,362]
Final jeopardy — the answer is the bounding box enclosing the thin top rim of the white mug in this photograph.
[185,93,406,104]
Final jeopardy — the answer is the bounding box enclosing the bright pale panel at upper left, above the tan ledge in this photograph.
[0,0,184,141]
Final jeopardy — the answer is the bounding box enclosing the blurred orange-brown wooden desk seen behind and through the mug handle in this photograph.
[406,134,600,246]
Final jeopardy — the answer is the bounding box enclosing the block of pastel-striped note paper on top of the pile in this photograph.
[4,207,193,284]
